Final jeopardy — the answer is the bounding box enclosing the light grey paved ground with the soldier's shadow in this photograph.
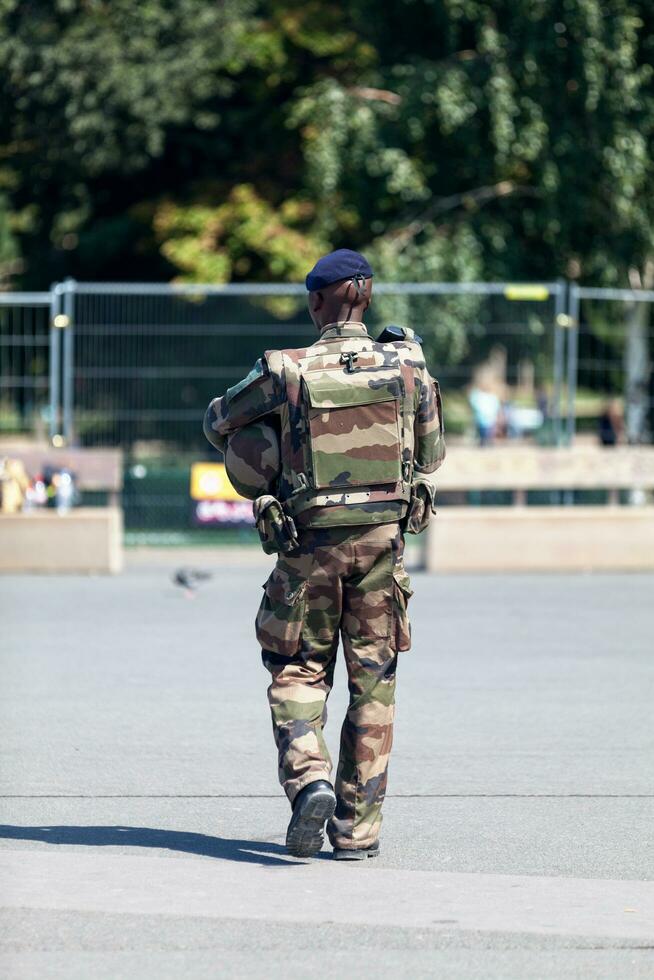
[0,556,654,980]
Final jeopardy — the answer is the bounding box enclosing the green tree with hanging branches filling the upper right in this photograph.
[284,0,654,284]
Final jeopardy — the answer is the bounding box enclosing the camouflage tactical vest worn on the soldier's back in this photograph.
[265,331,424,527]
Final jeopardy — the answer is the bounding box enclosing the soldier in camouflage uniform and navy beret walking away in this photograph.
[204,249,445,860]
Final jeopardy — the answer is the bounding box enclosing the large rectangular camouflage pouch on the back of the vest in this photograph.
[302,366,404,489]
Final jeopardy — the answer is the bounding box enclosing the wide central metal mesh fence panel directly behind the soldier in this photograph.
[64,283,563,532]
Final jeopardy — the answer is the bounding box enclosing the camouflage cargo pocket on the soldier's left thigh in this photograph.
[255,568,307,657]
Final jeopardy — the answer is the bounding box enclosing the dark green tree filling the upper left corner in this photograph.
[0,0,256,285]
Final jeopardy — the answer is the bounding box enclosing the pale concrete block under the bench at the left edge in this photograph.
[0,507,123,574]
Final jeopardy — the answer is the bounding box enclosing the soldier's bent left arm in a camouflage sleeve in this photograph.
[203,357,283,451]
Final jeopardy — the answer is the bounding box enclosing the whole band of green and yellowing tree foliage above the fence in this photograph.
[0,0,654,285]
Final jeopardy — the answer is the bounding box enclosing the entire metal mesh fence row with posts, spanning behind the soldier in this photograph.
[0,281,604,534]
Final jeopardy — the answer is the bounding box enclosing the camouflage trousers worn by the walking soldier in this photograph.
[256,524,411,848]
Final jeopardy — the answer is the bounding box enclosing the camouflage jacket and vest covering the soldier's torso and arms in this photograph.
[205,322,445,527]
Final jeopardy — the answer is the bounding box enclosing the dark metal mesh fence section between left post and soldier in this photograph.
[73,290,306,454]
